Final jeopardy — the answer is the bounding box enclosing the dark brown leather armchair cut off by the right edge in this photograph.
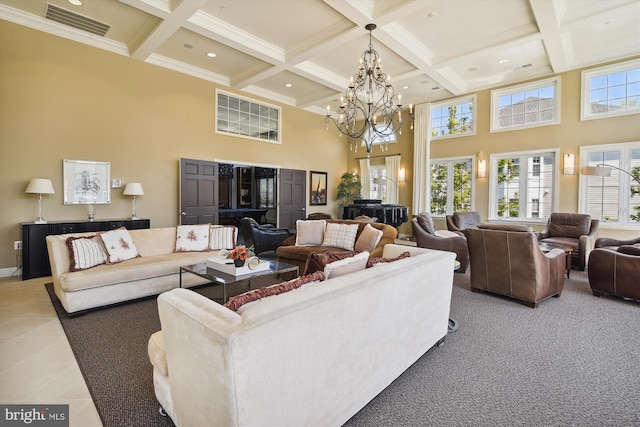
[588,237,640,301]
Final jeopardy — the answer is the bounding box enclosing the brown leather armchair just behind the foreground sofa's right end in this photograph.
[411,212,469,273]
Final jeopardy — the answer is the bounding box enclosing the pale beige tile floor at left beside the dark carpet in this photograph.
[0,277,102,427]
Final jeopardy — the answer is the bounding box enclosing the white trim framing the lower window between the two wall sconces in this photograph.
[489,148,560,224]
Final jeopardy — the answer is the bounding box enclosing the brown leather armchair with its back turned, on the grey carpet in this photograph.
[467,224,566,308]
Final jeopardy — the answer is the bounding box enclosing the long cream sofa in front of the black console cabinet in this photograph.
[46,227,218,314]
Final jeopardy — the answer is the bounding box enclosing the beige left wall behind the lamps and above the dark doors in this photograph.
[0,21,347,269]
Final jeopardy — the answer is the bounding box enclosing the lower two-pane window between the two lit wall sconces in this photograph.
[489,151,558,220]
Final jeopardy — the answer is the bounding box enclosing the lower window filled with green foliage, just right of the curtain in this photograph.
[431,158,473,215]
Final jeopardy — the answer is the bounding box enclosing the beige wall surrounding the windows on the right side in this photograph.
[348,59,640,238]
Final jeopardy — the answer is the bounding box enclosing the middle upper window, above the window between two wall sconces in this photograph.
[491,77,560,132]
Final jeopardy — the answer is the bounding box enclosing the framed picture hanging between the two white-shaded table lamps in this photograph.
[62,159,111,205]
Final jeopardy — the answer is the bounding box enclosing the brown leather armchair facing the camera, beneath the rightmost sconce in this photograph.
[538,212,600,271]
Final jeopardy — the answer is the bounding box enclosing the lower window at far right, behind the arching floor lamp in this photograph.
[580,142,640,226]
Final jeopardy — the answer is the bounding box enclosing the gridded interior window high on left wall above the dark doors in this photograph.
[216,89,281,143]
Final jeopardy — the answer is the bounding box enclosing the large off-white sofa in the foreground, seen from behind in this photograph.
[149,244,455,427]
